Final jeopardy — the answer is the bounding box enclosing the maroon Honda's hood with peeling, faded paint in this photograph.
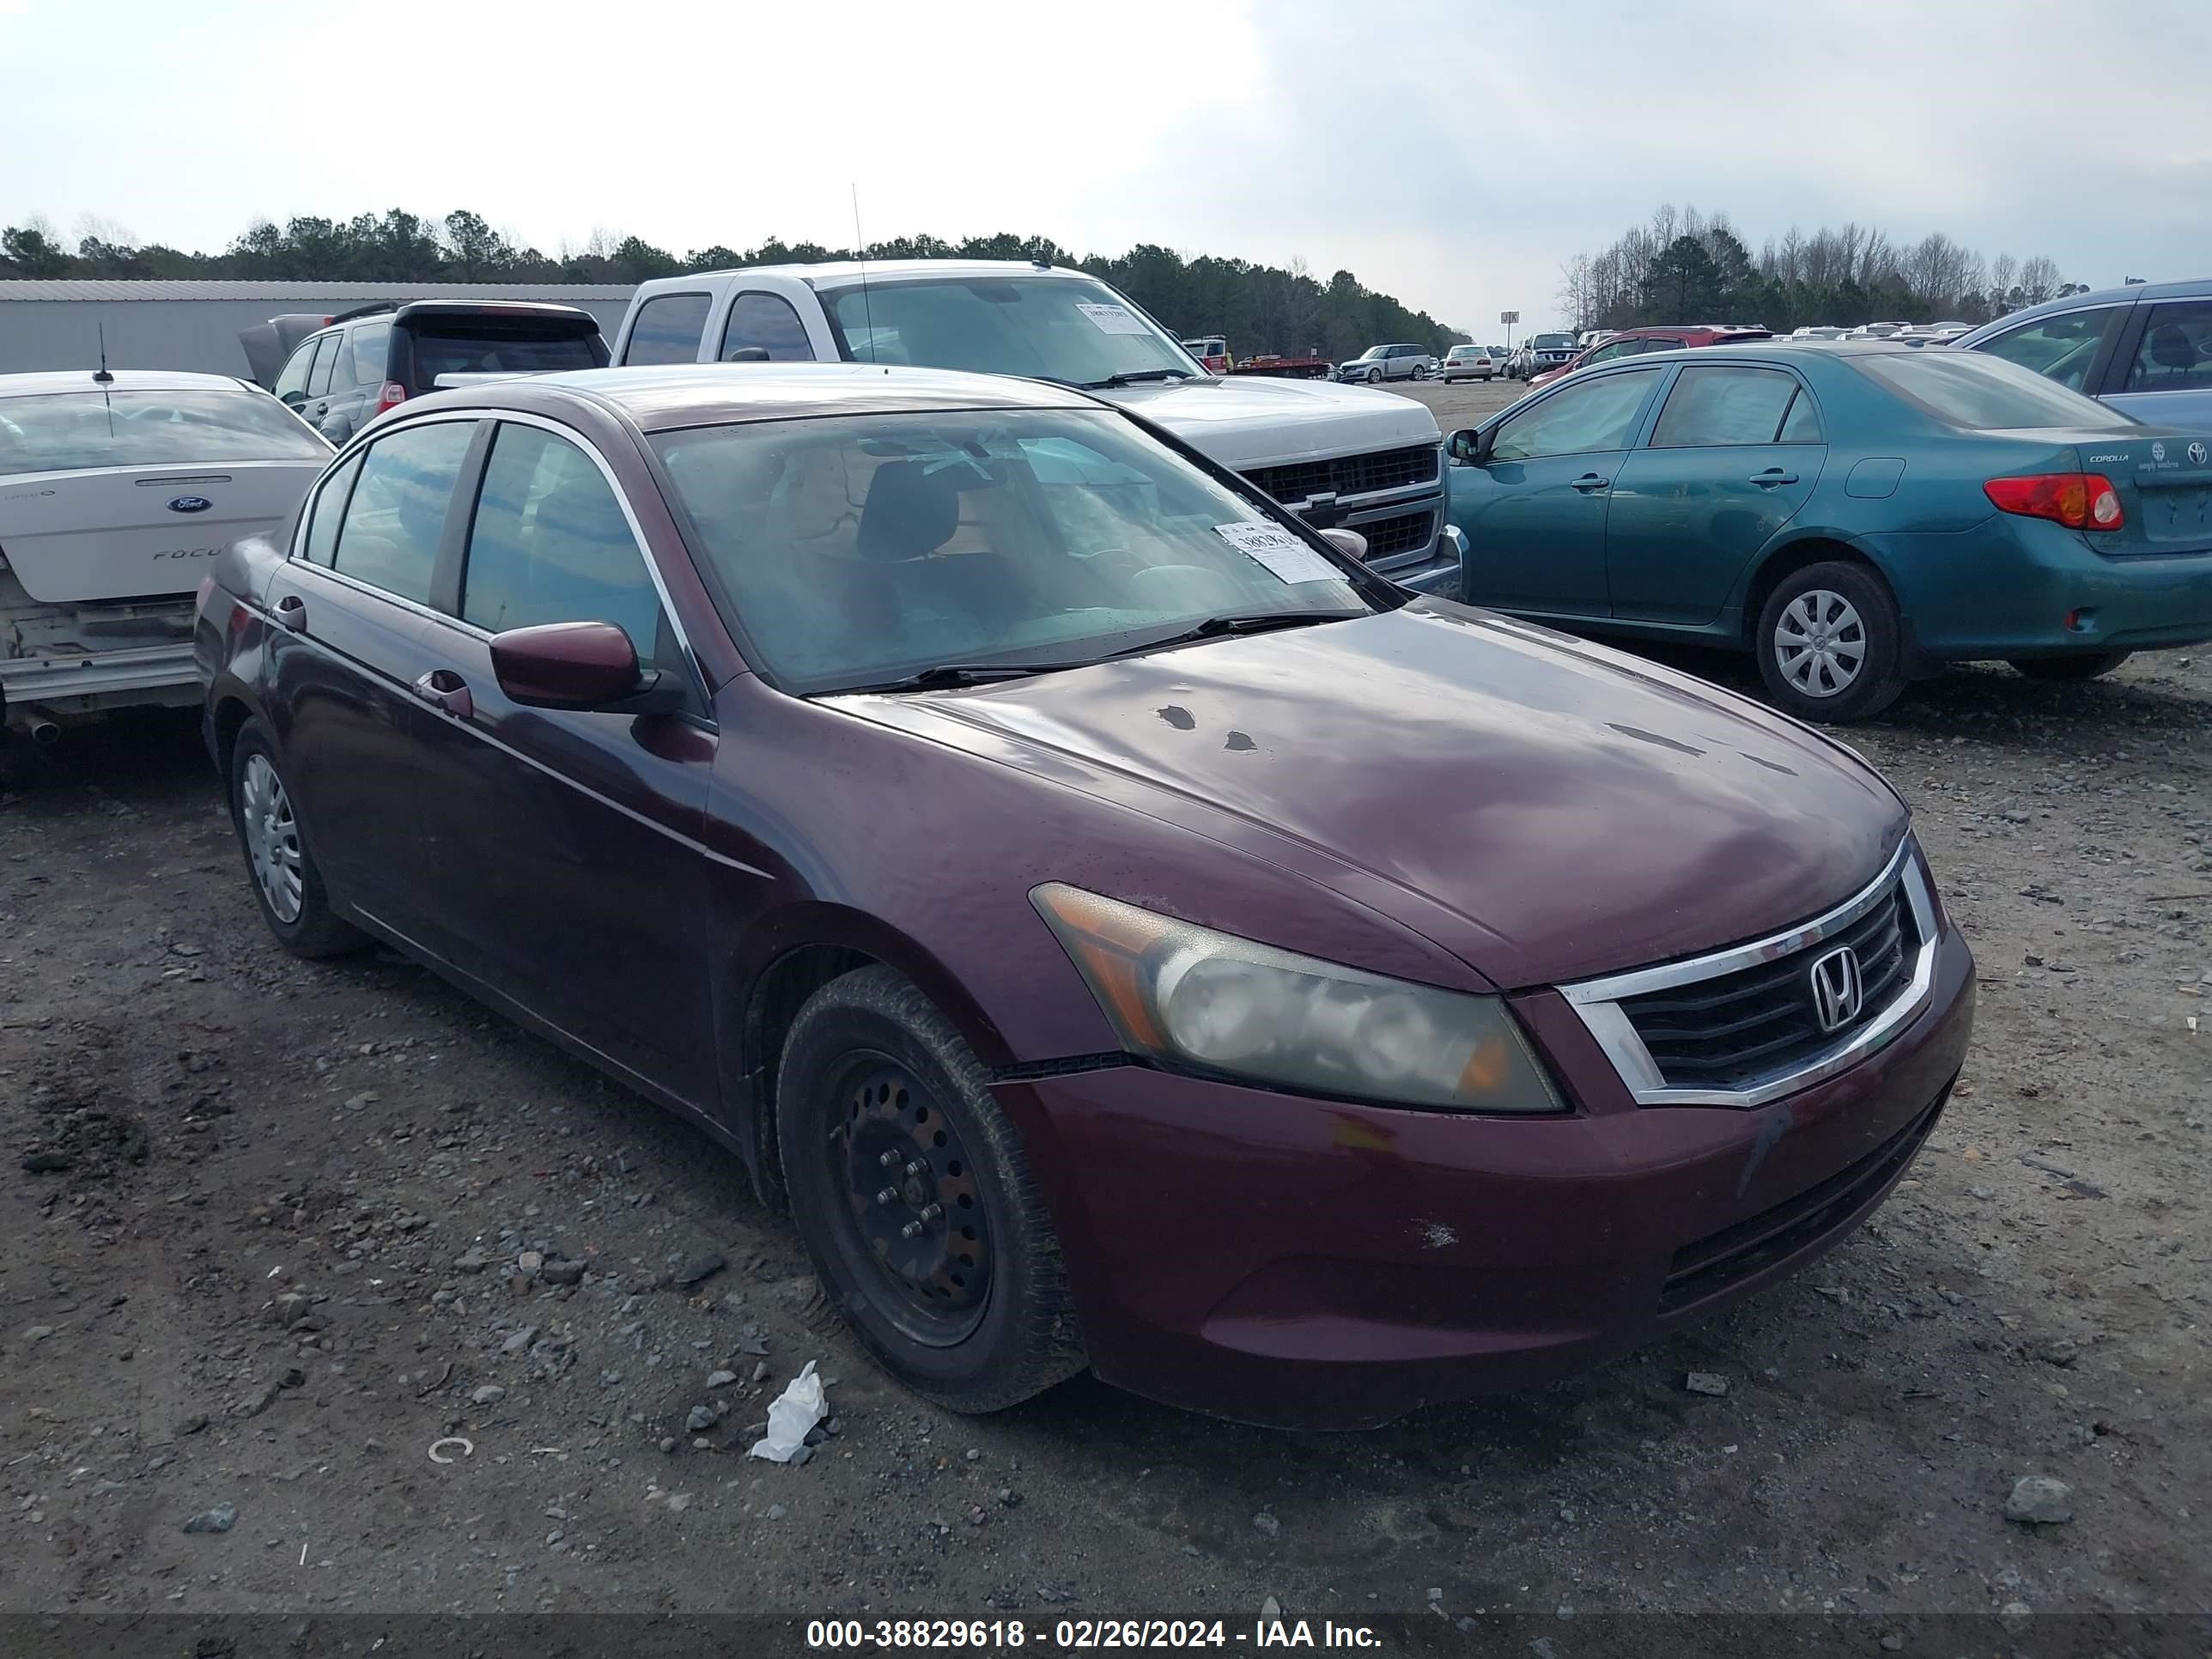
[832,599,1907,988]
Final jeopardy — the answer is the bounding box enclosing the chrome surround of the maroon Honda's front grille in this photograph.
[1559,836,1936,1110]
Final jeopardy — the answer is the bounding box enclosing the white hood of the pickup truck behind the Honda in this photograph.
[1097,374,1443,471]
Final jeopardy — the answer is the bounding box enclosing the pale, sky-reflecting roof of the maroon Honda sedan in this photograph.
[438,362,1106,431]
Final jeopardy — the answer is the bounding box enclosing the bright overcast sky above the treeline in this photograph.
[0,0,2212,337]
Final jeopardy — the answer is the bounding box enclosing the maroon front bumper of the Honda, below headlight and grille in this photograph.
[998,929,1973,1429]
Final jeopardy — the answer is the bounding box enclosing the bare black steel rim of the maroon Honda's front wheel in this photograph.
[830,1055,991,1345]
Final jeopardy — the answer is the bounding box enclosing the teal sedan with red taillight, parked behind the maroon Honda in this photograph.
[1449,341,2212,721]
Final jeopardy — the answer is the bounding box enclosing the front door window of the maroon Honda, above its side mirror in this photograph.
[460,425,664,664]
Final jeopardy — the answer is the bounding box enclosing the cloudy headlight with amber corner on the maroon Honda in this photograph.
[1030,883,1566,1113]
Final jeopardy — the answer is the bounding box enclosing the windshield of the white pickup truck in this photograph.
[821,276,1206,387]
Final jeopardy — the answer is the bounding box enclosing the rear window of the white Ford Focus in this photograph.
[0,389,330,476]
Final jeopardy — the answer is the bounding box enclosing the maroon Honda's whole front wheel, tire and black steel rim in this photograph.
[776,967,1088,1413]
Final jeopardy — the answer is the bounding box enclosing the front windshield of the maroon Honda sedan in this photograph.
[653,410,1374,695]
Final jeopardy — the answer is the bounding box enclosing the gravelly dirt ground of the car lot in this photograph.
[0,528,2212,1659]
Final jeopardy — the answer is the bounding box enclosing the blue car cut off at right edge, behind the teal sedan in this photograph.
[1954,279,2212,427]
